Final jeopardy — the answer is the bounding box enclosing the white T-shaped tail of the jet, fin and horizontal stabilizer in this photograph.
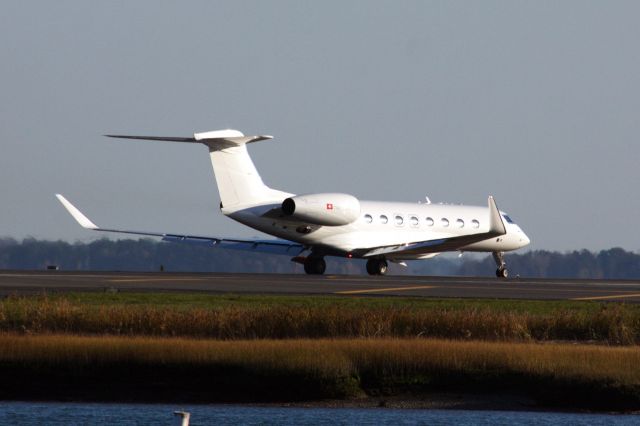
[105,129,291,208]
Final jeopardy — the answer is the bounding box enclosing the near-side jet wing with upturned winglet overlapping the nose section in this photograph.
[358,197,507,258]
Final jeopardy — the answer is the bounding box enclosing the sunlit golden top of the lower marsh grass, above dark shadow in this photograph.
[0,334,640,385]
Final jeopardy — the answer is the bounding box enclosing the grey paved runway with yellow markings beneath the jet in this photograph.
[0,271,640,303]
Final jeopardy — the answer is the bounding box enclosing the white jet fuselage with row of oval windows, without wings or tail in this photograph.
[222,200,529,260]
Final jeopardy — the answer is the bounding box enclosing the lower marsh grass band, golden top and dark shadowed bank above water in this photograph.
[0,334,640,410]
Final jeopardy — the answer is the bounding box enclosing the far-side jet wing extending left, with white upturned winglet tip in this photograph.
[56,194,305,256]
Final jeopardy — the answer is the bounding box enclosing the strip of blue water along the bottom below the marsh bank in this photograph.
[0,402,640,426]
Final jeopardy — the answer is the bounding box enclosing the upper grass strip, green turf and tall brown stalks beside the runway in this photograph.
[0,293,640,345]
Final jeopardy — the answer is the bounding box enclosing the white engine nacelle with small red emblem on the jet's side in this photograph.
[282,194,360,226]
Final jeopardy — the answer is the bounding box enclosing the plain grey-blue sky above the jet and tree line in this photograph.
[0,0,640,251]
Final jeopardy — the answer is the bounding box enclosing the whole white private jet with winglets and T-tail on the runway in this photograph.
[56,129,530,278]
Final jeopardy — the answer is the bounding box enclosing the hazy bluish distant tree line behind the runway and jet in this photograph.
[0,238,640,279]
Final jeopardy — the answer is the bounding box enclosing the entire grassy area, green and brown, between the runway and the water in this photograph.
[0,293,640,411]
